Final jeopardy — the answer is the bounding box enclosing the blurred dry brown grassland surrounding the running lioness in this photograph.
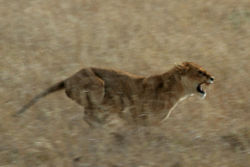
[0,0,250,167]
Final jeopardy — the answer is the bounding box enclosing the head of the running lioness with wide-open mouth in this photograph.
[179,62,214,98]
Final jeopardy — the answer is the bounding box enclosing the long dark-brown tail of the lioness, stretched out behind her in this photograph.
[15,81,65,116]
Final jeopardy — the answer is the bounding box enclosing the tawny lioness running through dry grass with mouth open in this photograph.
[17,62,214,126]
